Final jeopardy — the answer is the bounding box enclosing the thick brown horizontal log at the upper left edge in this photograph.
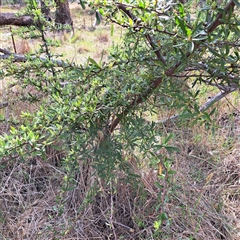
[0,12,34,26]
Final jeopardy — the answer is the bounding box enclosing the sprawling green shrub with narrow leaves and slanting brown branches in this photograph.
[0,1,240,238]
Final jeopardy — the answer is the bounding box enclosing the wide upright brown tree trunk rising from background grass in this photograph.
[55,0,73,28]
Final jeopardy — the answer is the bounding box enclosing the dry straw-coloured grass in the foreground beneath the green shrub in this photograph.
[0,121,240,240]
